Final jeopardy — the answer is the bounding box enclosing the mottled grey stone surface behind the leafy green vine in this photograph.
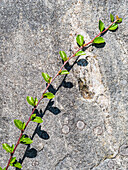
[0,0,128,170]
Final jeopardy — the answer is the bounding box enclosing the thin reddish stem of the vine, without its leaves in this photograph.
[6,20,117,170]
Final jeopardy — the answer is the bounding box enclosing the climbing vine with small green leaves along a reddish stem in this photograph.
[0,14,122,170]
